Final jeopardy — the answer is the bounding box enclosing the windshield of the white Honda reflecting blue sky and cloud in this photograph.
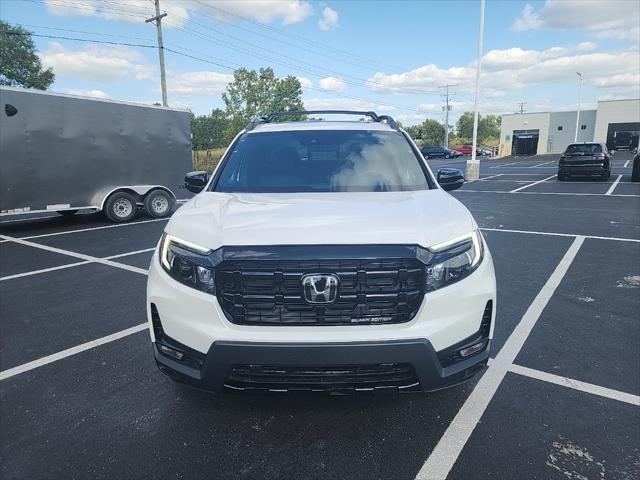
[213,130,430,193]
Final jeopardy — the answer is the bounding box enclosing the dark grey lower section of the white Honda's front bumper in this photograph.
[154,339,490,392]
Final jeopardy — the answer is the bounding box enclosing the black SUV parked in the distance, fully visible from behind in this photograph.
[558,142,611,181]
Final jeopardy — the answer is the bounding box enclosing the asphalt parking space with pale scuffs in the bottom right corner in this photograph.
[449,373,640,480]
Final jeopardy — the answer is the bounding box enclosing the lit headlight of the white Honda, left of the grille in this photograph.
[160,233,216,295]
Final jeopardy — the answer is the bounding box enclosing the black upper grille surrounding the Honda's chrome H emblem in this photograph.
[216,258,425,325]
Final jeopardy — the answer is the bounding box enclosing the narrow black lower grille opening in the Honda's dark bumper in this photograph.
[225,363,420,391]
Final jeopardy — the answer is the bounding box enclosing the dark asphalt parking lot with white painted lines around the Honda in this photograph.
[0,152,640,479]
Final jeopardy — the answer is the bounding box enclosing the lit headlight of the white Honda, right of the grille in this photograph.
[427,230,484,292]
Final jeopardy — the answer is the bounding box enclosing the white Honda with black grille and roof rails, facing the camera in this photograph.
[147,111,496,393]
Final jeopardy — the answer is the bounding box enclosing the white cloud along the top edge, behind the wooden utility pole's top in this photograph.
[44,0,312,27]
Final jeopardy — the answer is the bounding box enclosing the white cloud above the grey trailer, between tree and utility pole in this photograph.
[39,42,153,82]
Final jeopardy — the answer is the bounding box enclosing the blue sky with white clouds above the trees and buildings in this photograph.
[0,0,640,124]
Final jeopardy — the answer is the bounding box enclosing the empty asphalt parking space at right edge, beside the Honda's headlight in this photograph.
[516,239,640,395]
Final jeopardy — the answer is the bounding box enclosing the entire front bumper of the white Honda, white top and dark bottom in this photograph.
[147,245,496,391]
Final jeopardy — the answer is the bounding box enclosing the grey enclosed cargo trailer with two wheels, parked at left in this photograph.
[0,87,191,222]
